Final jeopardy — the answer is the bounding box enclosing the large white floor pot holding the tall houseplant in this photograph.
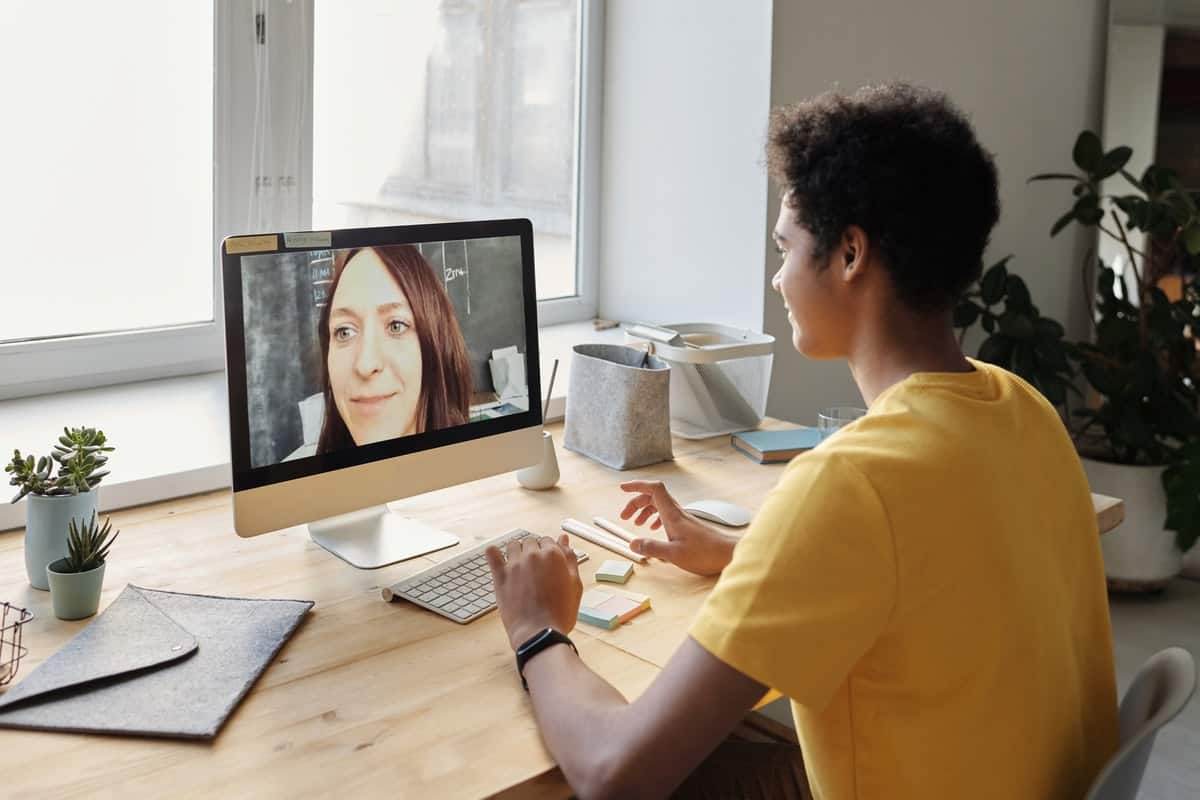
[1082,458,1183,591]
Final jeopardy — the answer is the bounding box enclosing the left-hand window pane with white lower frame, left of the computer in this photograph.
[0,0,221,396]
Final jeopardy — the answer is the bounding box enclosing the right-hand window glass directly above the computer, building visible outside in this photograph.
[312,0,581,300]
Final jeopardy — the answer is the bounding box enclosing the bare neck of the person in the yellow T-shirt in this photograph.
[847,313,973,405]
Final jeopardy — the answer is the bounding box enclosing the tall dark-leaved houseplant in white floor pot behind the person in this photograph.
[955,131,1200,589]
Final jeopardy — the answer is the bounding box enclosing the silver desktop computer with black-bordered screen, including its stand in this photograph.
[221,219,542,569]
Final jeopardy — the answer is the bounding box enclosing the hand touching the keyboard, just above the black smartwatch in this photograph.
[487,534,583,650]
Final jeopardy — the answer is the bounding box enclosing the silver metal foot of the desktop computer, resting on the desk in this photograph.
[308,506,458,570]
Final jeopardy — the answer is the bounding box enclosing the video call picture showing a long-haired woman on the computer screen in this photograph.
[241,236,529,468]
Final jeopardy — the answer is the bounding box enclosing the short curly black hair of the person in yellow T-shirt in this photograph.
[767,83,1000,312]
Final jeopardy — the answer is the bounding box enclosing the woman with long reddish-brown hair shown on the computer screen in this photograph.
[317,245,470,452]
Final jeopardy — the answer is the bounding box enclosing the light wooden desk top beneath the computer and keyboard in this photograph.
[0,423,1120,799]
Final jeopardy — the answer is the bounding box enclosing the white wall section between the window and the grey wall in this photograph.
[598,0,772,330]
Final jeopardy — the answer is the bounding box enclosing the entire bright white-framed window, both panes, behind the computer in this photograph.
[0,0,602,397]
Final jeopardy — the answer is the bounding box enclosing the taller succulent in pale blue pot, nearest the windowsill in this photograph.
[4,428,113,590]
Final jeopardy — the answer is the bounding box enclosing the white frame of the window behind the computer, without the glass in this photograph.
[0,0,605,399]
